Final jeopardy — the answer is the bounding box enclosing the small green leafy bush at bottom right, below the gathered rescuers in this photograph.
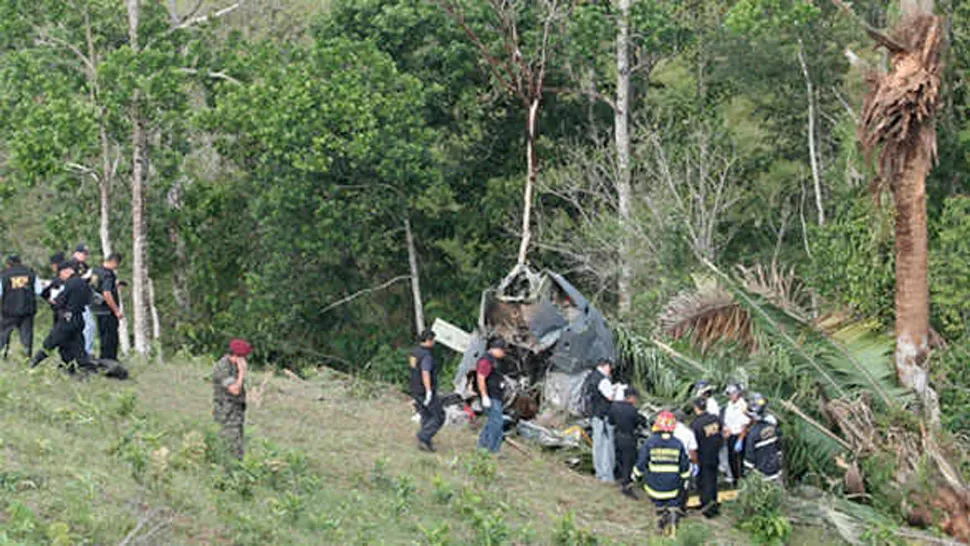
[733,474,792,546]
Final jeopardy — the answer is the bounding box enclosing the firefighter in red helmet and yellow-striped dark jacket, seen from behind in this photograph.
[634,411,690,531]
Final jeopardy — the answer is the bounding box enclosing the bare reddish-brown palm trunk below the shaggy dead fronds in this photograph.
[893,136,940,425]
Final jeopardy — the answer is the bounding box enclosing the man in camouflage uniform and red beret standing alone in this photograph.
[212,339,253,459]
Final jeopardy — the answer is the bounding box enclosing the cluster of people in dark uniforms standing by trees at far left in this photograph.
[0,244,124,370]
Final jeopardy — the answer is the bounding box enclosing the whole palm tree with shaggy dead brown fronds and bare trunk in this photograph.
[859,0,944,420]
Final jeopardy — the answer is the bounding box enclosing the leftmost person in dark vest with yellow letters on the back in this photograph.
[0,256,40,358]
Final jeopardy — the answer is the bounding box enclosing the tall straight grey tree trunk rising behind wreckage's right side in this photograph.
[614,0,633,316]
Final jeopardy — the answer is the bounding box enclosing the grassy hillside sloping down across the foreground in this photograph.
[0,358,848,545]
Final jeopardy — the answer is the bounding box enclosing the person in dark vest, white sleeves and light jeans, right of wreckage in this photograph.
[583,359,625,483]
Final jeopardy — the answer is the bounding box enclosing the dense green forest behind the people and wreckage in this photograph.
[0,0,970,536]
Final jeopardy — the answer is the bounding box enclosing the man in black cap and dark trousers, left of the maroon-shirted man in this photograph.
[408,330,445,453]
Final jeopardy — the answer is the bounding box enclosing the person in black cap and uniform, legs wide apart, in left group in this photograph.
[30,262,91,370]
